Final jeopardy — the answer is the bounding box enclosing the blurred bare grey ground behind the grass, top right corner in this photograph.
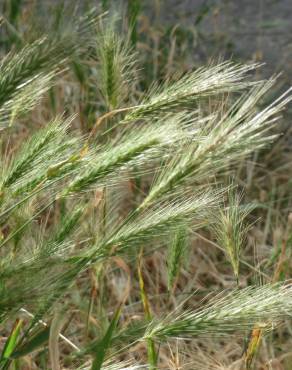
[152,0,292,82]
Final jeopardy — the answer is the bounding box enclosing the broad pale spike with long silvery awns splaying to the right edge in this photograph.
[141,80,292,207]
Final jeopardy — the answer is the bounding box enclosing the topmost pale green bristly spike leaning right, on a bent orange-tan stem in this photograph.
[124,62,258,121]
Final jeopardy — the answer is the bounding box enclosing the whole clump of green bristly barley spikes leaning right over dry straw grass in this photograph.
[0,13,292,370]
